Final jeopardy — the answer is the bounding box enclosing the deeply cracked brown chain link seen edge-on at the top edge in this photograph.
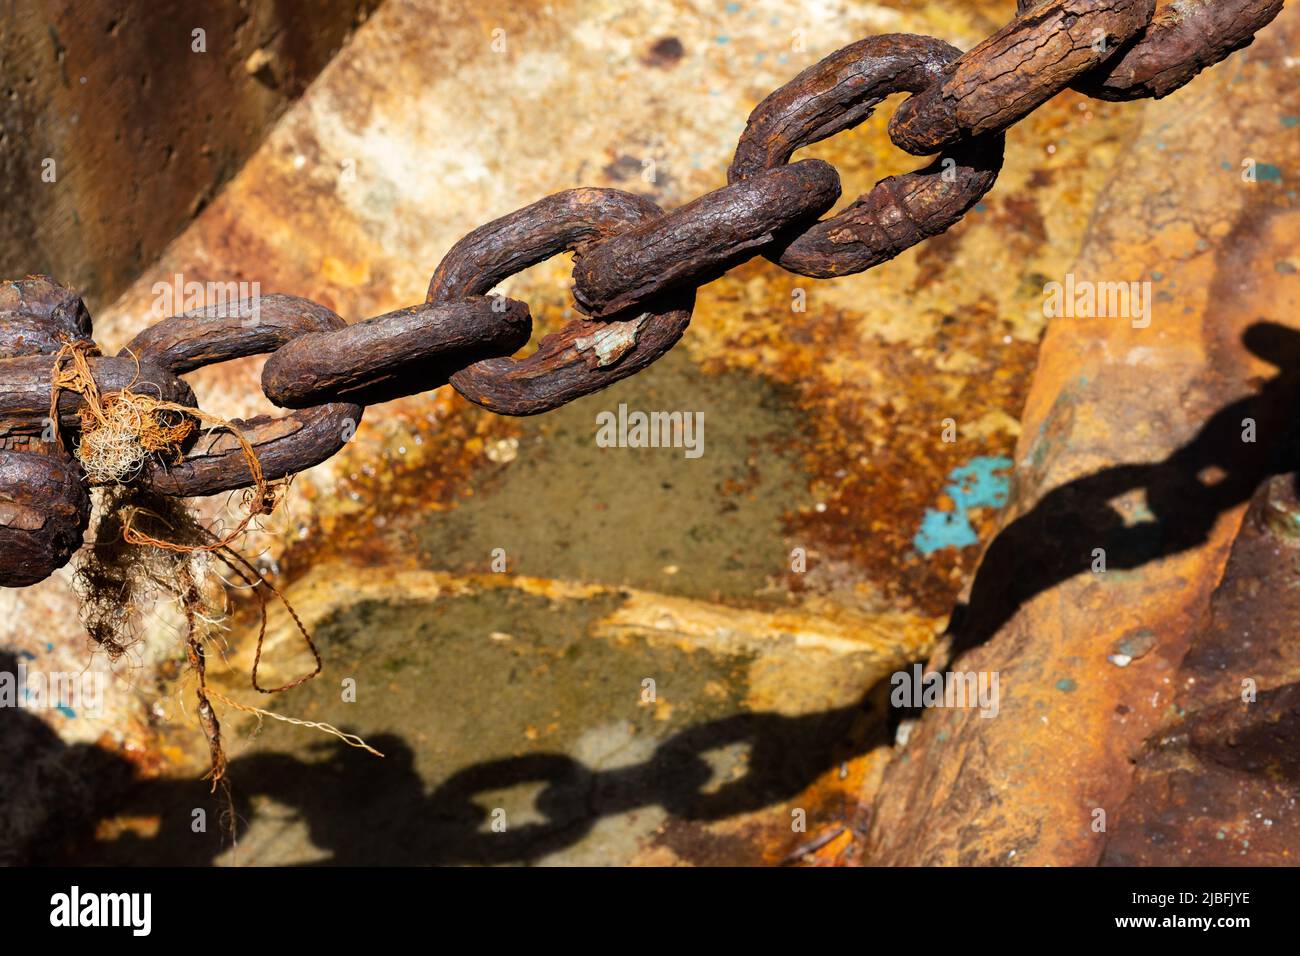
[889,0,1156,156]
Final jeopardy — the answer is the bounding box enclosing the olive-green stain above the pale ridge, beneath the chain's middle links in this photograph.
[417,351,811,600]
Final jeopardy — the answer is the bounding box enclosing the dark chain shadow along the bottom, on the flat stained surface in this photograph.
[45,702,891,866]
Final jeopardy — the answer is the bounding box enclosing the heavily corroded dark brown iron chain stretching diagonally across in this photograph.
[0,0,1282,587]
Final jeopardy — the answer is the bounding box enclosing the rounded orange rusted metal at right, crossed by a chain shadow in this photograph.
[866,0,1300,865]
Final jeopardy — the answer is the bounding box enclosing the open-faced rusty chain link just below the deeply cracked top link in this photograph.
[727,34,1004,278]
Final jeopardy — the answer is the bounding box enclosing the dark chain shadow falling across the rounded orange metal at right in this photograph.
[949,323,1300,659]
